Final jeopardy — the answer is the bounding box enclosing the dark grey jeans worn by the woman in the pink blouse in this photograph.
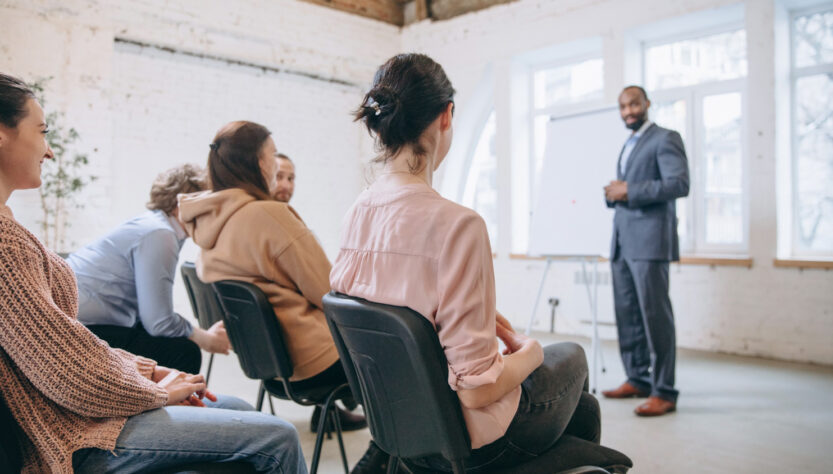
[410,342,601,472]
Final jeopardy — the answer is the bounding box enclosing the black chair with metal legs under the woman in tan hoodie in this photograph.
[212,280,350,474]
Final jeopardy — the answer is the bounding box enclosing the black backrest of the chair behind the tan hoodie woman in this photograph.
[211,280,294,381]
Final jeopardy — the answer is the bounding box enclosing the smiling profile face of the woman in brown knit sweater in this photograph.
[0,99,53,190]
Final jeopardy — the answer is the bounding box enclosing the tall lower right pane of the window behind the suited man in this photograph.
[703,92,743,244]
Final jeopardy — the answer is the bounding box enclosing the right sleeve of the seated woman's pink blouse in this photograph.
[435,213,503,390]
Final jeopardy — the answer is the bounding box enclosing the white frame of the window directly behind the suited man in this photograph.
[640,21,749,256]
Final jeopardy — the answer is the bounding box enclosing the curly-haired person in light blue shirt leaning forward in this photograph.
[67,164,229,374]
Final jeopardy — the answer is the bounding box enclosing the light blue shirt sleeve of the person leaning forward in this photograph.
[132,230,193,337]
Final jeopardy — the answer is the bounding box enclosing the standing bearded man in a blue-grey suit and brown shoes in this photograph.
[602,86,689,416]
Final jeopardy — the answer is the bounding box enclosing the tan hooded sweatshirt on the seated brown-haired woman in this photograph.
[179,189,338,381]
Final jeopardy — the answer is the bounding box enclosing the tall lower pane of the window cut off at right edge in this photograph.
[794,74,833,254]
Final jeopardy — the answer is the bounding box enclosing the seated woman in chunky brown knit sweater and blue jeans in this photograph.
[0,74,306,473]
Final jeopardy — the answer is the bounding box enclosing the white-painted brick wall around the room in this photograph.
[0,0,833,364]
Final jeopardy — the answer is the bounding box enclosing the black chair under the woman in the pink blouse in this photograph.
[324,292,633,474]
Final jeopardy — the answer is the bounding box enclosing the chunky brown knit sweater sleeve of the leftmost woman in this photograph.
[0,229,168,418]
